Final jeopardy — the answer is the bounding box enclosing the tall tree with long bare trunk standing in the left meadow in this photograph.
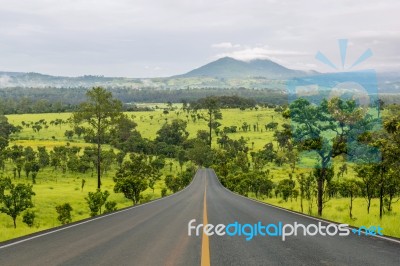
[72,87,122,189]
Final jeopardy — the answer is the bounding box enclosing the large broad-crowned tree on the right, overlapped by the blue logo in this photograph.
[284,97,373,216]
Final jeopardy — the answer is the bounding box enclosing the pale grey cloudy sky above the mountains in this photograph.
[0,0,400,77]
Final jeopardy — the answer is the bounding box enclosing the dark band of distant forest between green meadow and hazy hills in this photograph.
[0,87,287,114]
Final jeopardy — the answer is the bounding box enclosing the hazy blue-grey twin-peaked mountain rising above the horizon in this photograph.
[177,57,307,79]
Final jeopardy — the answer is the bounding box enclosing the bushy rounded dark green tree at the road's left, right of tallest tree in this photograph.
[114,153,157,205]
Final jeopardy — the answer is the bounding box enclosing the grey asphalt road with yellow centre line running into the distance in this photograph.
[0,169,400,266]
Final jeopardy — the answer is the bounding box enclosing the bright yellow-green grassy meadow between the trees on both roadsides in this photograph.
[0,104,400,241]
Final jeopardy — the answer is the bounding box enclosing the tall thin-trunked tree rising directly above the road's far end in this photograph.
[191,96,222,147]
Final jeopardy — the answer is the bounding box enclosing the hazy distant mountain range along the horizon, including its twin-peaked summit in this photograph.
[0,57,400,92]
